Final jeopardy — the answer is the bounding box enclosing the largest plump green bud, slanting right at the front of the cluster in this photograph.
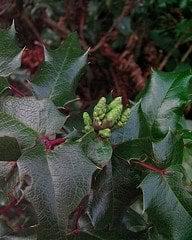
[102,105,123,128]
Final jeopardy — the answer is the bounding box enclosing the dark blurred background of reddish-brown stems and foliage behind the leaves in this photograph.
[0,0,192,107]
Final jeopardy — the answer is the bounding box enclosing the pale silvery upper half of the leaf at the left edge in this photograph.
[0,97,66,137]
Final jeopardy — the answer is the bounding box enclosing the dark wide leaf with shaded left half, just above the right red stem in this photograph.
[114,130,184,168]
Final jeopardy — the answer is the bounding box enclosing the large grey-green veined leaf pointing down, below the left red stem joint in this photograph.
[18,143,96,240]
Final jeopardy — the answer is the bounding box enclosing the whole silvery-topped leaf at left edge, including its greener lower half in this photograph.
[0,97,66,147]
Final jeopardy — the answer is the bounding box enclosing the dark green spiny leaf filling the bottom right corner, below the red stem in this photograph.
[140,167,192,240]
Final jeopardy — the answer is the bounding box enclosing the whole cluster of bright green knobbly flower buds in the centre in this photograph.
[83,97,130,138]
